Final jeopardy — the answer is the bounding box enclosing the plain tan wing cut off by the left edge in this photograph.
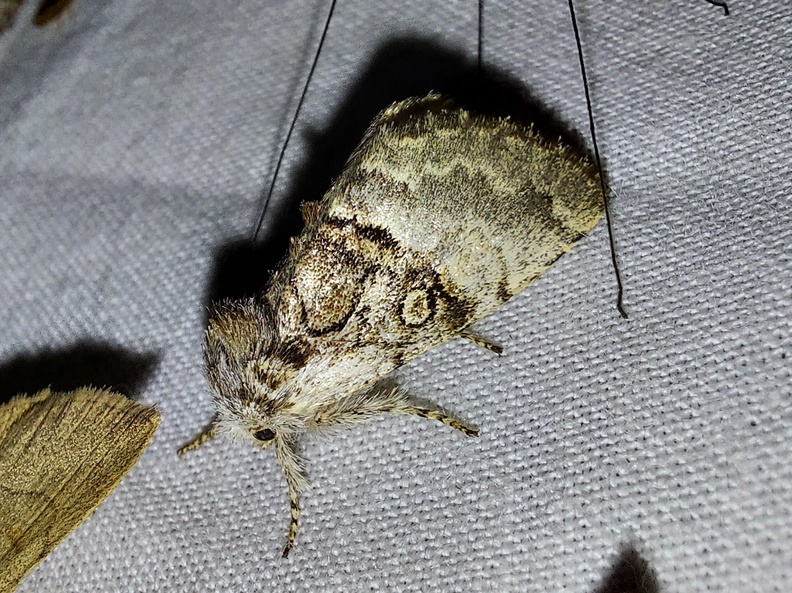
[0,388,159,593]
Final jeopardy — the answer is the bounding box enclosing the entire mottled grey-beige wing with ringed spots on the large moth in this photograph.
[270,95,604,377]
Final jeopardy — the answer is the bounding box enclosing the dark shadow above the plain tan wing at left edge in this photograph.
[0,341,160,404]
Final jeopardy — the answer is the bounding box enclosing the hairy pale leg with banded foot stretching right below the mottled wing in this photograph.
[314,386,478,436]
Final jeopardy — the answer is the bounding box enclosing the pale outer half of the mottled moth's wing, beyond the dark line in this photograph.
[326,95,603,319]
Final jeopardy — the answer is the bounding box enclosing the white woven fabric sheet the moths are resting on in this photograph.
[0,0,792,593]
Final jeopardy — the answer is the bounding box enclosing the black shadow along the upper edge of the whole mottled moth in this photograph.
[207,37,588,304]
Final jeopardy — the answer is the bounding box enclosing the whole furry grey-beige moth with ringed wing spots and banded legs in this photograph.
[179,94,604,557]
